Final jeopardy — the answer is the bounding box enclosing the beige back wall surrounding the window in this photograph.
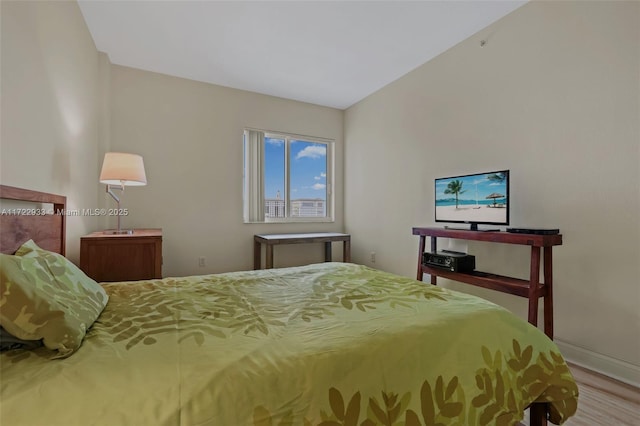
[105,66,343,276]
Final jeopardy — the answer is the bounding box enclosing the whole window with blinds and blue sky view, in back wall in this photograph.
[243,130,333,223]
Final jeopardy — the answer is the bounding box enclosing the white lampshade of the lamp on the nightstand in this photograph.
[100,152,147,186]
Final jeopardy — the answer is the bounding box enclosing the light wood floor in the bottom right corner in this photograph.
[524,364,640,426]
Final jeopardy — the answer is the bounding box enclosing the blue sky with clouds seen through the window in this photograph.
[264,137,327,199]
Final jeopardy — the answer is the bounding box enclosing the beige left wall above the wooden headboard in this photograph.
[0,1,99,262]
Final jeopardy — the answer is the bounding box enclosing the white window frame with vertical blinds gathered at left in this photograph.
[243,128,335,223]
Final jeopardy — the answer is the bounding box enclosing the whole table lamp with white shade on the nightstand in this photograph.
[100,152,147,234]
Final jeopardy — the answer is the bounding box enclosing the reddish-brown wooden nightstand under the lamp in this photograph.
[80,229,162,282]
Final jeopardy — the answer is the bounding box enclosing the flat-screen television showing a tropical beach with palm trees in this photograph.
[435,170,510,231]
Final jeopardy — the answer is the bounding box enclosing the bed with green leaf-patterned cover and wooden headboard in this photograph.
[0,186,578,426]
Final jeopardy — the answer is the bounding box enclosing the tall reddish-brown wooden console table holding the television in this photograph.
[413,228,562,339]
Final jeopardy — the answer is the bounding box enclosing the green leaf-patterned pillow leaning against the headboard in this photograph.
[0,240,108,358]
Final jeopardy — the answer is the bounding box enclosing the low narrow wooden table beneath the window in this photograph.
[253,232,351,269]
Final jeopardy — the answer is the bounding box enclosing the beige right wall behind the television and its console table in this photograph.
[345,2,640,383]
